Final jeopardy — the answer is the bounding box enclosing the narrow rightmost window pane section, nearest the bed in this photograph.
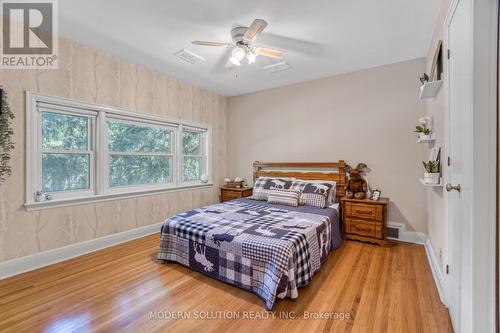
[182,130,205,182]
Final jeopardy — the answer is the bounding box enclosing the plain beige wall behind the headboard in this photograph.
[228,58,427,233]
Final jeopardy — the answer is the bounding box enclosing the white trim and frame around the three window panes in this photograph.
[25,91,213,210]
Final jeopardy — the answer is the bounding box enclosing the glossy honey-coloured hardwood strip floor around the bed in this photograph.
[0,235,452,332]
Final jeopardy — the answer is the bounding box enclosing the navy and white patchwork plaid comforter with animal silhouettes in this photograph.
[158,199,340,309]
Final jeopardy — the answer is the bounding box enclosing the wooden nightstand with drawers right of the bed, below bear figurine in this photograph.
[340,198,389,245]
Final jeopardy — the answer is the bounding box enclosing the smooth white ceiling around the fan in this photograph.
[59,0,439,96]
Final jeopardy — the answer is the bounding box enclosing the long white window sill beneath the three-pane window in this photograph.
[24,183,213,212]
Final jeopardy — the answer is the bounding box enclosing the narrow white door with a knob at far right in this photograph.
[448,0,471,332]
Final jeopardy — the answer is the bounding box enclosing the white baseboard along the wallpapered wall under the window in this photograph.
[0,223,162,280]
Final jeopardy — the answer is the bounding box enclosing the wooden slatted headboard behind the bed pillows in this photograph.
[253,160,346,197]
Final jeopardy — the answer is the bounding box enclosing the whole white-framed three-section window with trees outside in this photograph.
[26,92,210,208]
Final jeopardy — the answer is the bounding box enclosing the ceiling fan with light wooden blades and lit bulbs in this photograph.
[192,19,283,67]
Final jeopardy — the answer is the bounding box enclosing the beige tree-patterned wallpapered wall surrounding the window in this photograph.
[0,39,226,261]
